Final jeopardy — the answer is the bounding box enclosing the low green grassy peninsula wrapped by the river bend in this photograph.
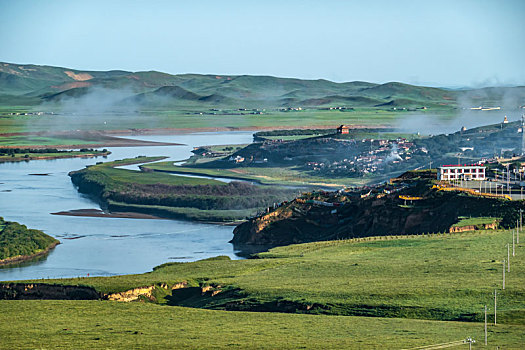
[70,157,296,222]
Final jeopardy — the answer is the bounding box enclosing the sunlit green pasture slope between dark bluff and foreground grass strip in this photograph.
[27,231,525,325]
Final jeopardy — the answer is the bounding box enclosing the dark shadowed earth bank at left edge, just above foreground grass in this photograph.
[0,283,102,300]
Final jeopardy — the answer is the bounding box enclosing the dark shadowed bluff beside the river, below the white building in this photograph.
[232,182,519,246]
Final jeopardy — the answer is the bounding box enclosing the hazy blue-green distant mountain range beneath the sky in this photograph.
[0,63,525,109]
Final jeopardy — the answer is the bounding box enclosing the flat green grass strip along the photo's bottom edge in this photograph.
[0,300,525,349]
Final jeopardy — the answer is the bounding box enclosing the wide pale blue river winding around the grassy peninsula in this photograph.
[0,131,253,281]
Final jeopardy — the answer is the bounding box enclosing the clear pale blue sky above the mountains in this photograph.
[0,0,525,87]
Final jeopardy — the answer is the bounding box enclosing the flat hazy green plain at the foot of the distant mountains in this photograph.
[0,108,454,133]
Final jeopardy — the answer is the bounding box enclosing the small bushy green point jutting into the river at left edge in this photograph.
[0,217,59,264]
